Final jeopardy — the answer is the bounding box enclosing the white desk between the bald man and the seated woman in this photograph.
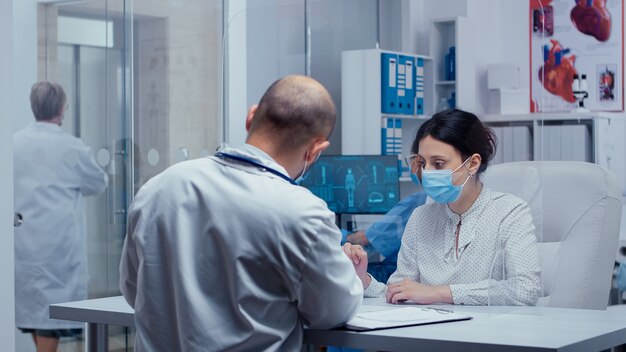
[50,297,626,352]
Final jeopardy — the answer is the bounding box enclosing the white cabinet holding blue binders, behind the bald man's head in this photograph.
[341,49,435,195]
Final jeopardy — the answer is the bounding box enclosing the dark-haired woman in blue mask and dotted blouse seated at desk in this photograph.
[344,110,541,305]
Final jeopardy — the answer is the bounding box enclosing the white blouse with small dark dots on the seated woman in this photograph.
[364,187,541,305]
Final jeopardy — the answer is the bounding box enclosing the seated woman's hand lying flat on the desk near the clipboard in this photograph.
[387,279,454,304]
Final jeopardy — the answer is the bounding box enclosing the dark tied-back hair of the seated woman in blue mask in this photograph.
[411,109,497,173]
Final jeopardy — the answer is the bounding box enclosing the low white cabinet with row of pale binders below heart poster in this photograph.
[482,112,626,189]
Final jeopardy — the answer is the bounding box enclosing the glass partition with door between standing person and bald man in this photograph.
[38,0,222,350]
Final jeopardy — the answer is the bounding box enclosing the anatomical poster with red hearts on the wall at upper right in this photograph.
[530,0,624,112]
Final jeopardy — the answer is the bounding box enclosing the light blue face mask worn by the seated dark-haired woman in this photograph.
[411,158,472,203]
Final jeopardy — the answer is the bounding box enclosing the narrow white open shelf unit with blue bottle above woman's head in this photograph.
[430,17,476,111]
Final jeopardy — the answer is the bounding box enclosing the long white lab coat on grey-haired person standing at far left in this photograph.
[13,122,108,329]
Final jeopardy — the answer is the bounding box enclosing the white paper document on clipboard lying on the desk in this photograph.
[346,307,472,331]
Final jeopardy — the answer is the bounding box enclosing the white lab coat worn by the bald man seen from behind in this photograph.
[120,145,363,352]
